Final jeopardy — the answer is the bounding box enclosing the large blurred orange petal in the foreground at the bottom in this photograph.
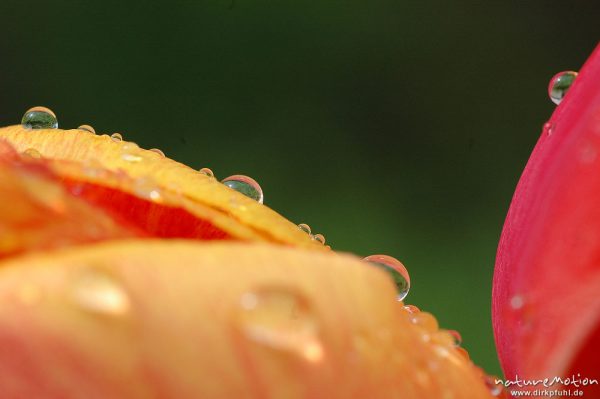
[0,240,490,399]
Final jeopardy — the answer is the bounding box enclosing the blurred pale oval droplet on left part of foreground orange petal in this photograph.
[72,269,131,316]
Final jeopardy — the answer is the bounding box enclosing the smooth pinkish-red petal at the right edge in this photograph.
[492,46,600,390]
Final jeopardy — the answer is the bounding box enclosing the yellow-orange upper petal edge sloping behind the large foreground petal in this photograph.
[0,125,323,249]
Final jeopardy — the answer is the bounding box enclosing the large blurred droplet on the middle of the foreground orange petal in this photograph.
[239,288,324,363]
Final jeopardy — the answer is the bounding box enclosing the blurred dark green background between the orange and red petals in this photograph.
[0,0,600,374]
